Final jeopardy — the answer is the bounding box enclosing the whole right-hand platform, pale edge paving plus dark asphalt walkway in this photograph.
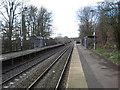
[66,44,120,90]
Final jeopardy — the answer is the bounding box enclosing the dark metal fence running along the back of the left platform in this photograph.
[2,40,56,54]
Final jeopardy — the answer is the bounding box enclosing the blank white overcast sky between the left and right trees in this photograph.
[30,0,103,37]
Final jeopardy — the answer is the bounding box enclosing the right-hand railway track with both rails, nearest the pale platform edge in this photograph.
[26,46,73,90]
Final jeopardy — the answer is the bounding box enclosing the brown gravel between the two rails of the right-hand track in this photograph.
[31,46,70,89]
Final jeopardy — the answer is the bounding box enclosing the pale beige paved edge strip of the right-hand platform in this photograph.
[66,44,88,88]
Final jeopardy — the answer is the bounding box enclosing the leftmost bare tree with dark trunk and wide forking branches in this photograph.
[0,0,21,51]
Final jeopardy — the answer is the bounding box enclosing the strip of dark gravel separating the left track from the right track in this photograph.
[14,45,69,88]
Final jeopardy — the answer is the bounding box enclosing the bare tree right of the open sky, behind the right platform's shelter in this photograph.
[77,7,93,39]
